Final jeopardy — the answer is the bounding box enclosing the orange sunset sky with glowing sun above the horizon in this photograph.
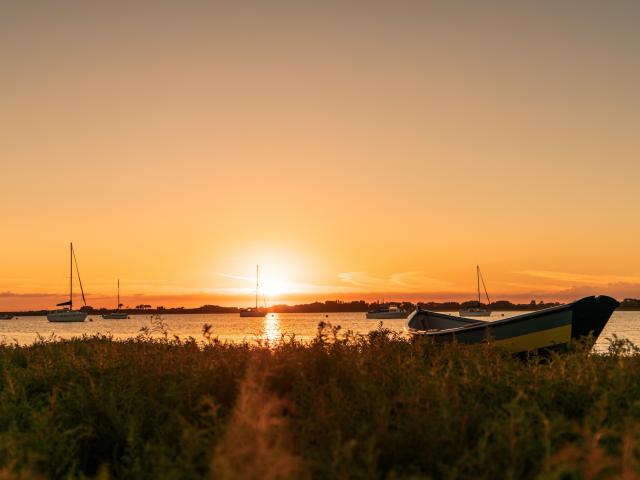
[0,0,640,310]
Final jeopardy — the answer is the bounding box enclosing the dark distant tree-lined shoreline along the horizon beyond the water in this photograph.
[5,299,640,317]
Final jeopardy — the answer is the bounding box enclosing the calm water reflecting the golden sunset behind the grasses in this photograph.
[0,311,640,351]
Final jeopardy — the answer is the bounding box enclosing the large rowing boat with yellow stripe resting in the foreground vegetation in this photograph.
[409,295,620,353]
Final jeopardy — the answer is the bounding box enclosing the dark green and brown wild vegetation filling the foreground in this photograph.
[0,326,640,479]
